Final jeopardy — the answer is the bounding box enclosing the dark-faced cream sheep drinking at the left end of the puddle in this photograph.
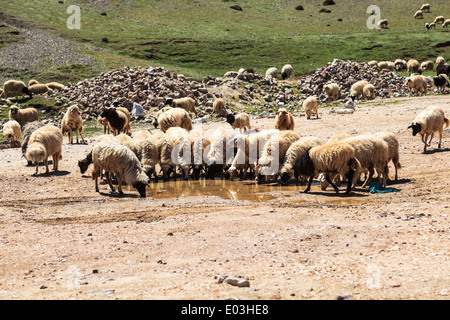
[92,141,149,198]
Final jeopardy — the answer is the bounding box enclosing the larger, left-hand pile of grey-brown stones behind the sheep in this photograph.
[56,67,214,118]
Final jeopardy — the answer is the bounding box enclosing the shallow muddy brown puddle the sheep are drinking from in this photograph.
[132,179,374,205]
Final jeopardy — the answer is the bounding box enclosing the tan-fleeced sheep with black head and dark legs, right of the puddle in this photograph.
[294,141,361,194]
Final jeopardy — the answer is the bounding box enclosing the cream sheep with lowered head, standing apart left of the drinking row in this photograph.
[25,125,63,174]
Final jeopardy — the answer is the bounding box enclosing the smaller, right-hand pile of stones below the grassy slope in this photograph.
[297,60,408,101]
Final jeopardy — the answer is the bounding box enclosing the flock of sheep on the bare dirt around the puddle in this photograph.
[3,81,450,197]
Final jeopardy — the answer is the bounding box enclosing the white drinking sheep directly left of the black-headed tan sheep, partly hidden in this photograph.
[279,137,322,184]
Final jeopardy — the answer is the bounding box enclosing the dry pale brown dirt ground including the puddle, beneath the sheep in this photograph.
[0,96,450,300]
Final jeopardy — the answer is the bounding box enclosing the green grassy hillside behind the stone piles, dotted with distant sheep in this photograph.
[0,0,450,79]
